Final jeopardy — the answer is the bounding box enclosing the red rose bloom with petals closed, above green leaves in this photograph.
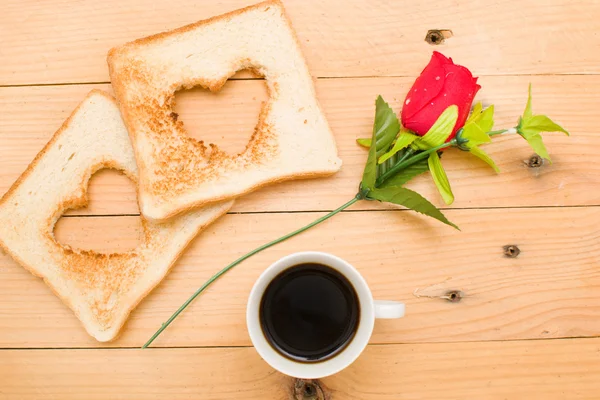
[401,51,481,140]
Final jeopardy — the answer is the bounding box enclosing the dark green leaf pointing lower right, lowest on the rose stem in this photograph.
[368,186,458,229]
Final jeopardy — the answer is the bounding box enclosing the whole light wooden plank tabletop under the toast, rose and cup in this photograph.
[0,0,600,400]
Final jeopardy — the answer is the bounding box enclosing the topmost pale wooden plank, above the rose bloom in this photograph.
[0,0,600,85]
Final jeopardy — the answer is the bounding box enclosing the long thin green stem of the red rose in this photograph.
[142,131,480,349]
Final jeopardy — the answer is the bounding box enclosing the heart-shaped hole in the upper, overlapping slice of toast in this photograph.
[172,70,269,156]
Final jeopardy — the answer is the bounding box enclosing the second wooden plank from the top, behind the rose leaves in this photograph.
[0,76,600,215]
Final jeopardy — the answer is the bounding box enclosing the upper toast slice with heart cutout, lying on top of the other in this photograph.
[108,0,341,220]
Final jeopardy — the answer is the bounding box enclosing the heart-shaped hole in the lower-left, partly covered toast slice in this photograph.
[54,169,144,254]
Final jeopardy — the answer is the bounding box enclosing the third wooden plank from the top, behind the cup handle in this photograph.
[0,207,600,348]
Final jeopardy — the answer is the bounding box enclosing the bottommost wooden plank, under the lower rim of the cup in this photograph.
[0,338,600,400]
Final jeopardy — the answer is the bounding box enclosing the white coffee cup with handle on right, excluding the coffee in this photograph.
[246,251,404,379]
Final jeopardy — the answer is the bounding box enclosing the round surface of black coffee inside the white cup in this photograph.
[260,264,360,362]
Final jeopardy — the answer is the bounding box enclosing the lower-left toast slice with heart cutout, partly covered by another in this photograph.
[0,91,233,342]
